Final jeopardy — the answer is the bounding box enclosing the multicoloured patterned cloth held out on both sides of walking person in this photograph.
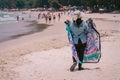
[66,19,101,64]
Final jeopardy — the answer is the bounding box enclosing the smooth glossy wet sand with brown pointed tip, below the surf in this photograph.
[0,21,50,42]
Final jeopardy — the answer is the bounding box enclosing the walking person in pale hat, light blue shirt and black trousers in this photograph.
[66,10,89,71]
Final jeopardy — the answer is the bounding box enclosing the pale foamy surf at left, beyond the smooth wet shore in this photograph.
[0,12,37,24]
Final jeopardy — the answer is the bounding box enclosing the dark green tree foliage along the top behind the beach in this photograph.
[0,0,120,9]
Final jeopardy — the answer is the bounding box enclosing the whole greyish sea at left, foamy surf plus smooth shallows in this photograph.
[0,12,37,42]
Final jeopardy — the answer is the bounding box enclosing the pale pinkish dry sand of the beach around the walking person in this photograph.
[0,13,120,80]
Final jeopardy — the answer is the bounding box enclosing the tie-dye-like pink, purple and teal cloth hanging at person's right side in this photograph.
[83,19,101,63]
